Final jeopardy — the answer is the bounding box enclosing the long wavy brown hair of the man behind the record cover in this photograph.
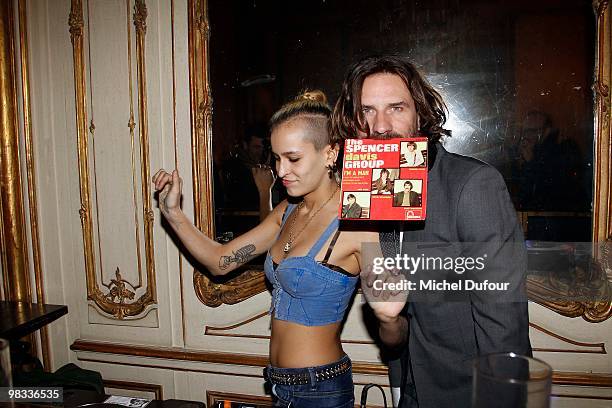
[330,55,451,142]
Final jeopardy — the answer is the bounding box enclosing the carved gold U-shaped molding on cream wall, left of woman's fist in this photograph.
[68,0,157,319]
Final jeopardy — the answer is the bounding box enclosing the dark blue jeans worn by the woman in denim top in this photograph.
[272,356,355,408]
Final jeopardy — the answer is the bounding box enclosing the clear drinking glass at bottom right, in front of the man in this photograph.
[472,353,552,408]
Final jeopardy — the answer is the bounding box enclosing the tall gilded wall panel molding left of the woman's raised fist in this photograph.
[68,0,157,319]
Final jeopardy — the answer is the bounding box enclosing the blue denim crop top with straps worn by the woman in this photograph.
[264,204,357,326]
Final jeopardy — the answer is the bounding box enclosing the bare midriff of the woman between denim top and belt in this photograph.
[270,318,344,368]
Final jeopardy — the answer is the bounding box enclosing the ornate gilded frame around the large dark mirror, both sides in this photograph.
[189,0,612,322]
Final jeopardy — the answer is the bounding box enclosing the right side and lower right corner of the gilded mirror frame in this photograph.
[527,0,612,323]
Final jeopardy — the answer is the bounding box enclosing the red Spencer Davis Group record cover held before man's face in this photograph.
[338,137,427,221]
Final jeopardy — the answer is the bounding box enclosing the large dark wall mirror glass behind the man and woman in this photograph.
[189,0,609,322]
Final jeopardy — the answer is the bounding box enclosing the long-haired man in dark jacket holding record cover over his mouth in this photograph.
[332,56,531,408]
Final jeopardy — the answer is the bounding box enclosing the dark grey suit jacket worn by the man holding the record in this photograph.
[381,143,531,408]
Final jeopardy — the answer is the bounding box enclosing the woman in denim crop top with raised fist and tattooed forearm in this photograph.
[153,92,378,408]
